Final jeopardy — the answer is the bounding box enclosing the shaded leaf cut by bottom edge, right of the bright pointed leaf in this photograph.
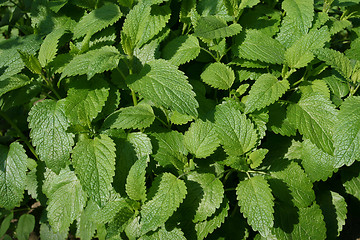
[275,203,326,240]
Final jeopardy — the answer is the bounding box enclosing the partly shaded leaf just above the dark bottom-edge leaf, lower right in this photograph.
[271,162,315,208]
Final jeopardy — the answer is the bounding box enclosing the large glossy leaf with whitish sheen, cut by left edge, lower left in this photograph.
[0,142,27,209]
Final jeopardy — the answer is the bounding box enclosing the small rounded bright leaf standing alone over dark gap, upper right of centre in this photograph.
[200,62,235,90]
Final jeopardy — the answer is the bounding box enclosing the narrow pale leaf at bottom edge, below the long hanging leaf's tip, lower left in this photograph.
[76,200,99,240]
